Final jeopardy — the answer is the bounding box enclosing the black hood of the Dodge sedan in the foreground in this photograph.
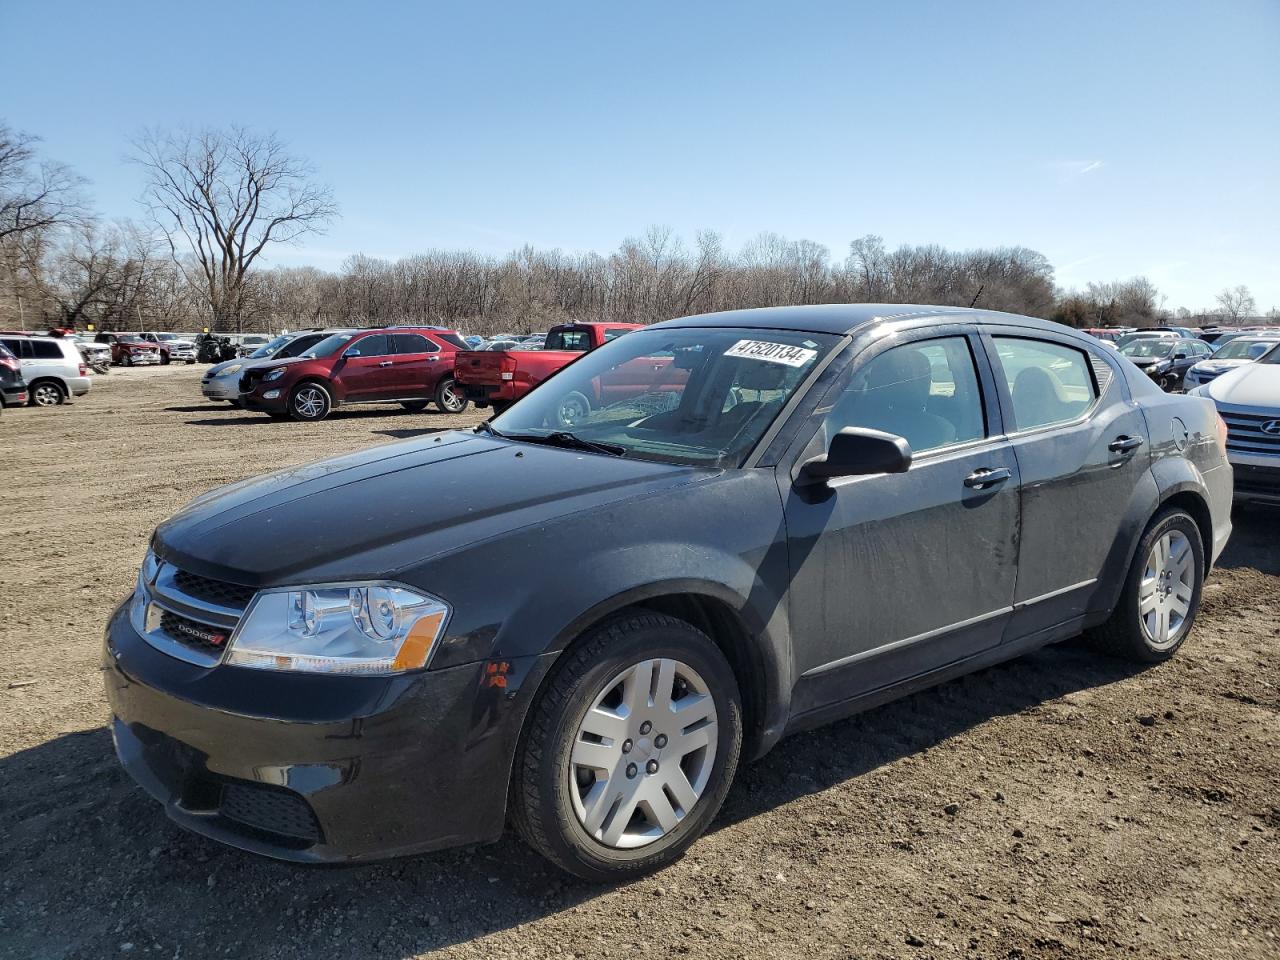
[154,431,722,586]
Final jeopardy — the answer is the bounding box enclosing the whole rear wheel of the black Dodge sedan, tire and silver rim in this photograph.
[1091,508,1204,663]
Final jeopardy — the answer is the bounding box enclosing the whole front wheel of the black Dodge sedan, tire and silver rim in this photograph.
[513,613,742,882]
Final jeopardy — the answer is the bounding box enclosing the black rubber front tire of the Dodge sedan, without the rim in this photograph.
[512,613,742,883]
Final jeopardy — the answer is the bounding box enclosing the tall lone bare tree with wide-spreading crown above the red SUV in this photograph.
[132,127,338,330]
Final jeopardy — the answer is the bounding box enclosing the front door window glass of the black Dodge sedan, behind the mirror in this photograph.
[823,337,987,453]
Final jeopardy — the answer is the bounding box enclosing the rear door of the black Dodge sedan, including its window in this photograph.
[983,326,1149,637]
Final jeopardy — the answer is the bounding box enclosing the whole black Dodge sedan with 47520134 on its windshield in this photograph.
[104,305,1231,881]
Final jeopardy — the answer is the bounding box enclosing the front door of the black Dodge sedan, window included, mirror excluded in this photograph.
[783,328,1019,713]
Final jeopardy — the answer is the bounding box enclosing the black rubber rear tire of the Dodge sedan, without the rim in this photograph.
[1088,508,1204,663]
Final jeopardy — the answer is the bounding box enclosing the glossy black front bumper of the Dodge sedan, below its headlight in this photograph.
[104,605,539,863]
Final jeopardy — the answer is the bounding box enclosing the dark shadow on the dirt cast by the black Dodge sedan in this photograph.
[0,645,1134,957]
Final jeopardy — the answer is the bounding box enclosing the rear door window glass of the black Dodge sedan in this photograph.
[992,337,1098,430]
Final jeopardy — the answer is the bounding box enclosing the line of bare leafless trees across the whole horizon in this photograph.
[0,124,1256,334]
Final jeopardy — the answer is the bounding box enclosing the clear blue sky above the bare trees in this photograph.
[0,0,1280,310]
